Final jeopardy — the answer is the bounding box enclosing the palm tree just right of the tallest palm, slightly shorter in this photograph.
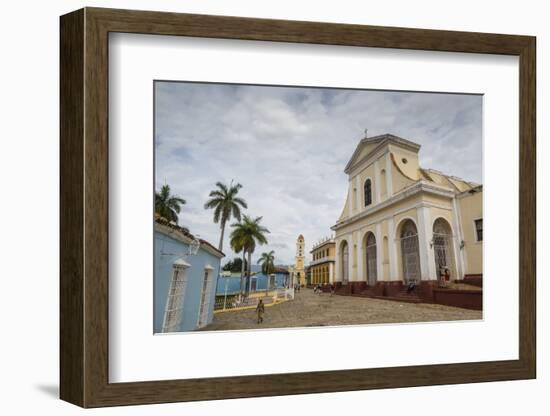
[231,215,269,300]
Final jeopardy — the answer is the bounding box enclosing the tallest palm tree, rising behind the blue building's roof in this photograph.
[204,181,248,251]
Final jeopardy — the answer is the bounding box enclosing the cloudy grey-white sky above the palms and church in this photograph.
[155,82,482,264]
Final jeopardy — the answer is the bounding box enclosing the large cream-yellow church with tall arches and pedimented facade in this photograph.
[331,134,483,298]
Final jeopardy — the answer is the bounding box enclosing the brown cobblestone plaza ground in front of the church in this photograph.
[203,289,482,331]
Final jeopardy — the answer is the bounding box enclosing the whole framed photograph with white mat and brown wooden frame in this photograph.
[60,8,536,407]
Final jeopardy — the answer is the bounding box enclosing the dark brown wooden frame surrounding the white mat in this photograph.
[60,8,536,407]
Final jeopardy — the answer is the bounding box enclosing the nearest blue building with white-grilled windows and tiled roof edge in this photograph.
[154,216,224,333]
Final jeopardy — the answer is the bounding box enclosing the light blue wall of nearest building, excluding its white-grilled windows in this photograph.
[153,230,220,333]
